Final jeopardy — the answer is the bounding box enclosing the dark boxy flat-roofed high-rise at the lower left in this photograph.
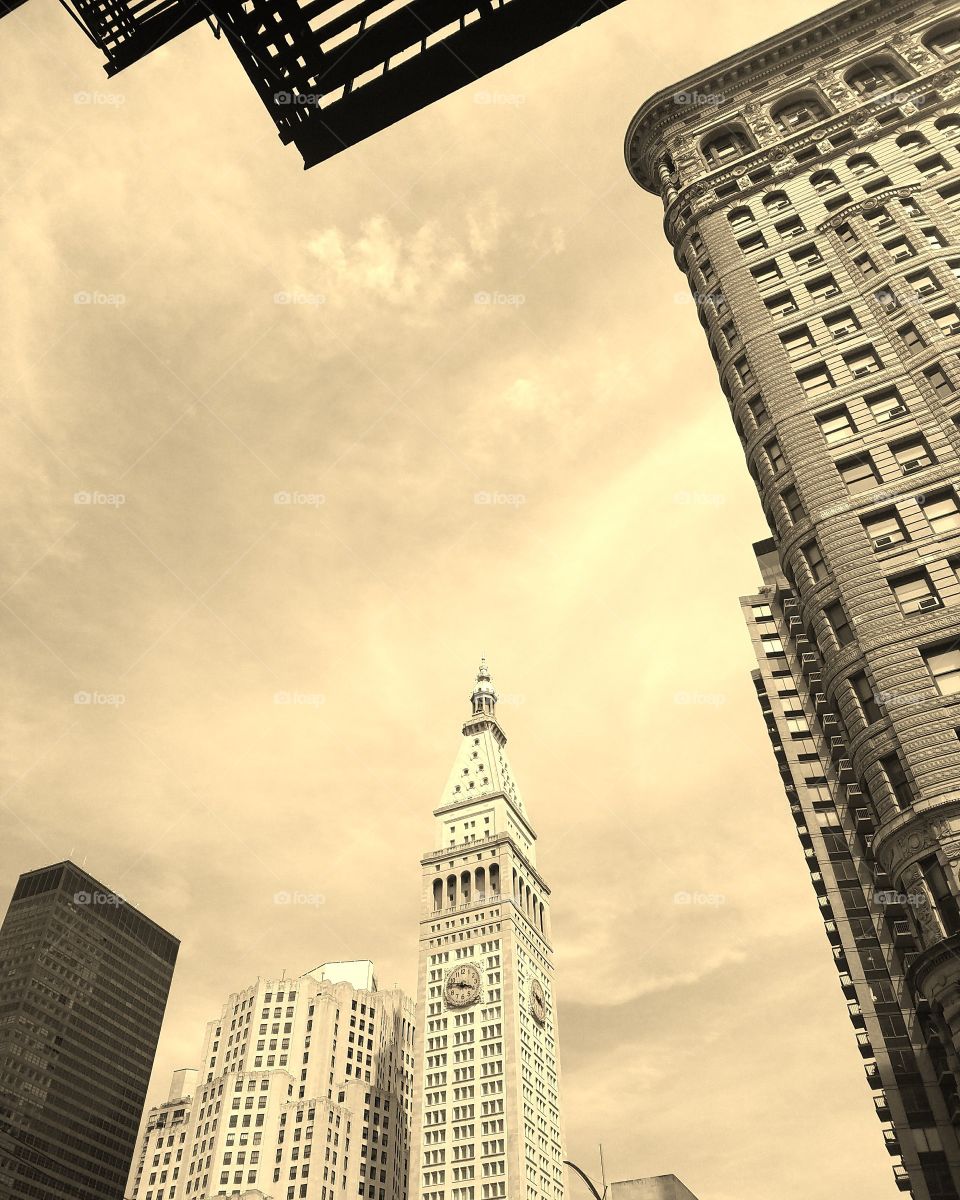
[0,863,180,1200]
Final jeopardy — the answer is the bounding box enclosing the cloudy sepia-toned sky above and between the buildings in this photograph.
[0,0,894,1200]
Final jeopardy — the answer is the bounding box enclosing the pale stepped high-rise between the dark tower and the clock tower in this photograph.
[131,960,414,1200]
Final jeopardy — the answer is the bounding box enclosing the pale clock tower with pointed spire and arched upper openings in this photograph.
[410,662,564,1200]
